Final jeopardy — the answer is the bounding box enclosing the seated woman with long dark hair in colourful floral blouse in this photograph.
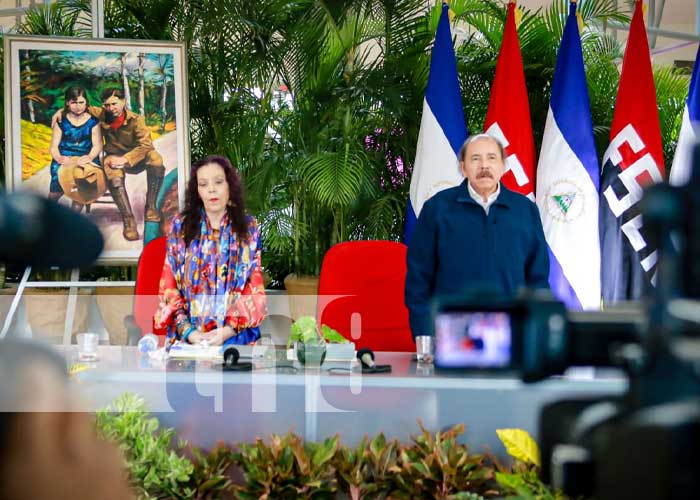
[155,156,267,345]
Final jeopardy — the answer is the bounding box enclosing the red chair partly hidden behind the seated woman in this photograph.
[124,236,167,345]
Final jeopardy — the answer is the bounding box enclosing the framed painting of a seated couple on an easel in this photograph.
[4,35,190,264]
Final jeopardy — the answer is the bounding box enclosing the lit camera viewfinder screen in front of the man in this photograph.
[435,312,512,368]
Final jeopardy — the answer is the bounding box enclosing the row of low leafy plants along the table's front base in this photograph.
[97,393,566,500]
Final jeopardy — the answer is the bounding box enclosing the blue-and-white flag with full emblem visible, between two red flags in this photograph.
[536,2,600,310]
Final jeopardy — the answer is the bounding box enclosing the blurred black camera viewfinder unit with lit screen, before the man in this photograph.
[433,290,644,382]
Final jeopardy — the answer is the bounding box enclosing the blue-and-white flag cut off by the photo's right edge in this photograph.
[668,46,700,186]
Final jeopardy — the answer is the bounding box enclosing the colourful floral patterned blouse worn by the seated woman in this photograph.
[154,210,267,344]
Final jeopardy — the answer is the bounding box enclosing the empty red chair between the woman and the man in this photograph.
[317,241,416,352]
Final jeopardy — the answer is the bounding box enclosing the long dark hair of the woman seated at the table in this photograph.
[182,156,248,245]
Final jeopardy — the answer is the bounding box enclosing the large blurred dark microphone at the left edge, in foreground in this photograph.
[0,193,104,268]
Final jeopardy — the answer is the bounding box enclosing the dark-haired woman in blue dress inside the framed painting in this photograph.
[49,86,102,209]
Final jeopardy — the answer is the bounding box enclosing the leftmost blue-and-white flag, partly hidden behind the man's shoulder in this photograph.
[404,3,467,245]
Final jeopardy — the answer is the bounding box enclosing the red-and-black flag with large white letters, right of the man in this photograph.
[600,0,665,306]
